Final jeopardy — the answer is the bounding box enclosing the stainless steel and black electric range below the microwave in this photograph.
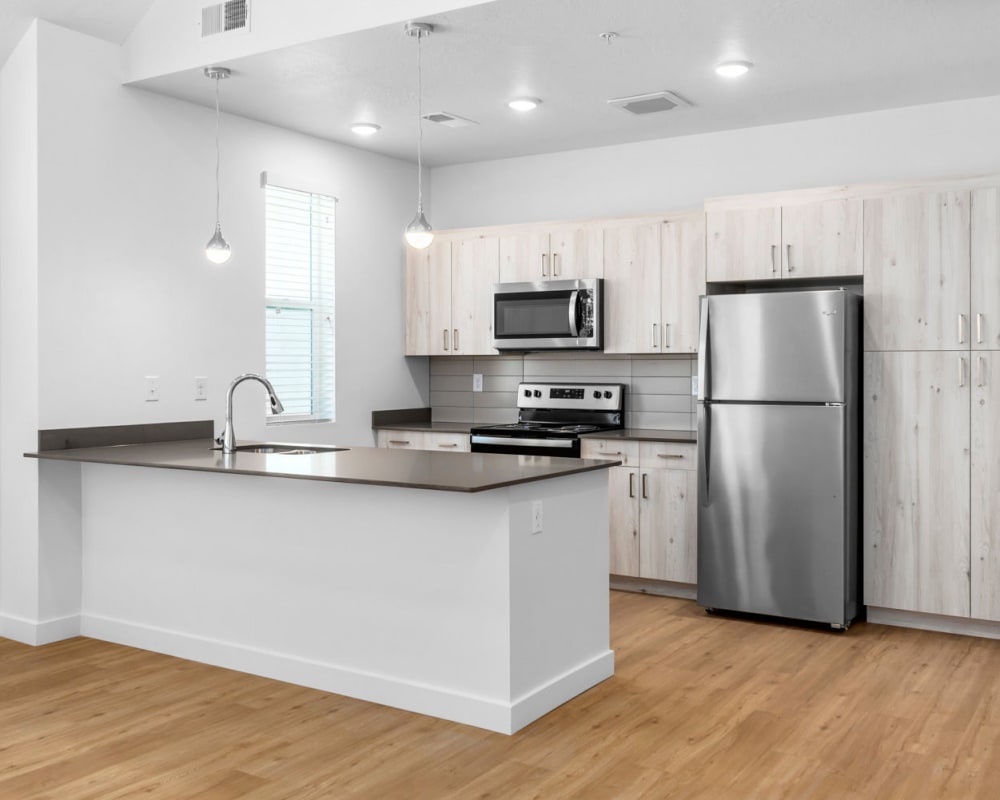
[472,383,625,458]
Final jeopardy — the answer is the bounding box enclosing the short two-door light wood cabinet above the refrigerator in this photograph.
[706,197,863,282]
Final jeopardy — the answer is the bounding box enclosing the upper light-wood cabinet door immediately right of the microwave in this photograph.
[604,222,661,353]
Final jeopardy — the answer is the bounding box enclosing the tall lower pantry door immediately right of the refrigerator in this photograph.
[863,352,970,617]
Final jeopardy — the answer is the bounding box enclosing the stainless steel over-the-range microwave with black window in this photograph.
[493,278,604,350]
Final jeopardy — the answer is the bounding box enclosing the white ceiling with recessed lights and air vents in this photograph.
[0,0,1000,165]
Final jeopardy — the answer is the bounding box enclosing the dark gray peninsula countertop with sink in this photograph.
[25,439,621,492]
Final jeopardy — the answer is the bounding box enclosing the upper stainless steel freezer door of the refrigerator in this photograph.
[699,289,857,403]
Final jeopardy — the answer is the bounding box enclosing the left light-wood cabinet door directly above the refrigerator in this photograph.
[705,207,781,281]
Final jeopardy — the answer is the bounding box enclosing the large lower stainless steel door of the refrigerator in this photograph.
[698,403,857,625]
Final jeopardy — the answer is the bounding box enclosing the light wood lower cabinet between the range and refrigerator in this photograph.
[582,439,698,583]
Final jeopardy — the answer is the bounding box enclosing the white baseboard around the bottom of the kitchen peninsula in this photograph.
[80,615,614,734]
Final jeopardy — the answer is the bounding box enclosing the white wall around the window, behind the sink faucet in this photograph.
[39,23,427,444]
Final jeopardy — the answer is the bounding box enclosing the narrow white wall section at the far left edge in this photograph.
[0,25,39,636]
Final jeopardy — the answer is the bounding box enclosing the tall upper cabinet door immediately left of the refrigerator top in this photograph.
[660,214,705,353]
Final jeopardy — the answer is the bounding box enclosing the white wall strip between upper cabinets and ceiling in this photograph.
[430,96,1000,229]
